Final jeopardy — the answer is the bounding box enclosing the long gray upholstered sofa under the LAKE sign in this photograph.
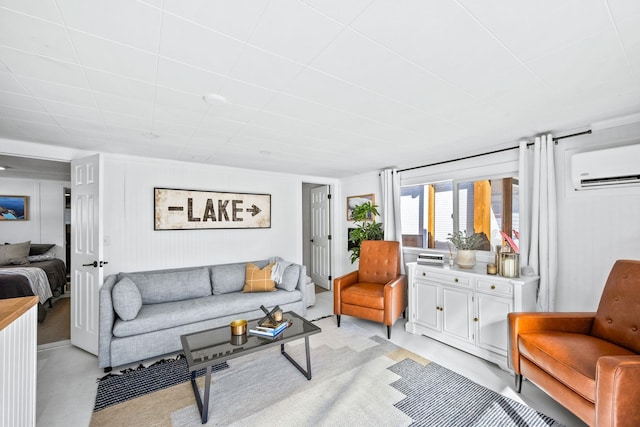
[98,258,307,370]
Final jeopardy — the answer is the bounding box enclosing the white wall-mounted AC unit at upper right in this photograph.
[571,144,640,190]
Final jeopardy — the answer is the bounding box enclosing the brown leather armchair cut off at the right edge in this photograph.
[509,260,640,427]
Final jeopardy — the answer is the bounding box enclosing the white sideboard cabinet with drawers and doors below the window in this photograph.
[405,262,538,370]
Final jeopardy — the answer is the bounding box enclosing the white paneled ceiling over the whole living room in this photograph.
[0,0,640,177]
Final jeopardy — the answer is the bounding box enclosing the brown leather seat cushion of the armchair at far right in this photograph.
[518,331,635,402]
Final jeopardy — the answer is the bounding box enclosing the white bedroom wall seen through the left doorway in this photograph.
[0,178,70,262]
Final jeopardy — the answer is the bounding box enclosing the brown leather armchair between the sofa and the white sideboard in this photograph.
[333,240,407,338]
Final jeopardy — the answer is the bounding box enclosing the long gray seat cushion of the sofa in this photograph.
[113,290,302,338]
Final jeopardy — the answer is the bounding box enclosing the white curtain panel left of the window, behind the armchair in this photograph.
[380,169,404,273]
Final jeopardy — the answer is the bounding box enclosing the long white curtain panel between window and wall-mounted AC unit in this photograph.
[519,134,558,311]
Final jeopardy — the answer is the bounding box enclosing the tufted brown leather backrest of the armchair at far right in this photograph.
[591,260,640,353]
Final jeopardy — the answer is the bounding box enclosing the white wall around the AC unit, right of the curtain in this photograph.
[555,124,640,311]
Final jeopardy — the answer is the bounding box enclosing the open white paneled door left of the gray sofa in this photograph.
[71,154,103,355]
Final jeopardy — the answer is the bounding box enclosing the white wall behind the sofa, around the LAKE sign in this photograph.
[103,155,334,275]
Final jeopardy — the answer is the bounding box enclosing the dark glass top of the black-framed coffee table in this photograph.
[181,311,322,371]
